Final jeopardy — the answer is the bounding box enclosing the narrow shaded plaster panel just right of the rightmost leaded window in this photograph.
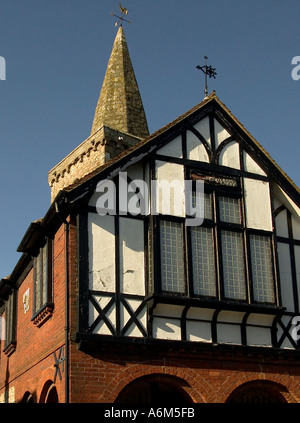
[277,242,294,311]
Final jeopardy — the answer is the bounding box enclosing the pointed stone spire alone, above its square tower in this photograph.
[91,26,149,138]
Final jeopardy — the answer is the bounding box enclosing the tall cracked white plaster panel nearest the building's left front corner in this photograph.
[88,213,115,292]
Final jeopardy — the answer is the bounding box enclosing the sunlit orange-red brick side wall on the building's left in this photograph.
[0,225,65,401]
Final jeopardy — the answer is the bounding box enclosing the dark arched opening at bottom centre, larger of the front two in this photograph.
[115,374,192,405]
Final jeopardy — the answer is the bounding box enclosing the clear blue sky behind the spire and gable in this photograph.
[0,0,300,277]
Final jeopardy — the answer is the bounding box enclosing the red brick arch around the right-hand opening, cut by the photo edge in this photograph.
[215,373,300,403]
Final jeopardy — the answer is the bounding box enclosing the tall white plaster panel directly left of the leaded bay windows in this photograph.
[119,218,145,295]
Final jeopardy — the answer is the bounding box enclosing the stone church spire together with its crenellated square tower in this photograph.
[48,27,149,201]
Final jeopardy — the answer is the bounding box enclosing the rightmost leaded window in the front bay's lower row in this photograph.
[250,234,275,303]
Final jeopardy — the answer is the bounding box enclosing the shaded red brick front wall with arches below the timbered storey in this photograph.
[67,344,300,403]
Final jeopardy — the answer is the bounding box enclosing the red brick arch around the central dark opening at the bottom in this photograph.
[101,361,213,403]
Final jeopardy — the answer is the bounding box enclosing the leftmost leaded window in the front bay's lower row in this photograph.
[160,220,185,293]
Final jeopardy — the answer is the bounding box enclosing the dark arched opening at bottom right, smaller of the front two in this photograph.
[226,381,287,404]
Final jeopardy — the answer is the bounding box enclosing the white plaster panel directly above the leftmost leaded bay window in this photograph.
[155,161,185,217]
